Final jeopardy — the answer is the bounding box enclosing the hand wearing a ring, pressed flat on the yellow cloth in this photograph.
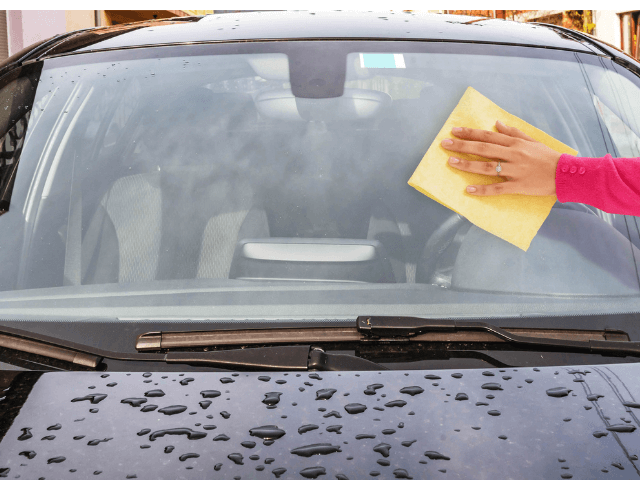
[441,121,561,196]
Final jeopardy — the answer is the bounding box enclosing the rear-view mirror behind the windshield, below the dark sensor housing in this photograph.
[255,88,392,122]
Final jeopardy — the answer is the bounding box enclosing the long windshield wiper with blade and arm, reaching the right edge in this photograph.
[136,316,640,357]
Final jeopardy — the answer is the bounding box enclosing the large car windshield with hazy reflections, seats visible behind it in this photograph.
[0,41,640,319]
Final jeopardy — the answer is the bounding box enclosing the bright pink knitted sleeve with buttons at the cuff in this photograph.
[556,153,640,216]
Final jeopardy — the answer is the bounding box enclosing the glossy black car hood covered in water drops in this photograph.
[0,364,640,479]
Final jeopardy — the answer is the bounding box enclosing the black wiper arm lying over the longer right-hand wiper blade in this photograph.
[357,316,640,357]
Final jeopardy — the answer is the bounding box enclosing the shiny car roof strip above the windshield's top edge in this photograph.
[20,11,596,62]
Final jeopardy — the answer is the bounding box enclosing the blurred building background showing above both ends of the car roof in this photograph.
[0,6,640,61]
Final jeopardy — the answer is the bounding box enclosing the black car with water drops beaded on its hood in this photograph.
[0,12,640,479]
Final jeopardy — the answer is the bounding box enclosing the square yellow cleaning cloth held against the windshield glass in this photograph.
[409,87,578,252]
